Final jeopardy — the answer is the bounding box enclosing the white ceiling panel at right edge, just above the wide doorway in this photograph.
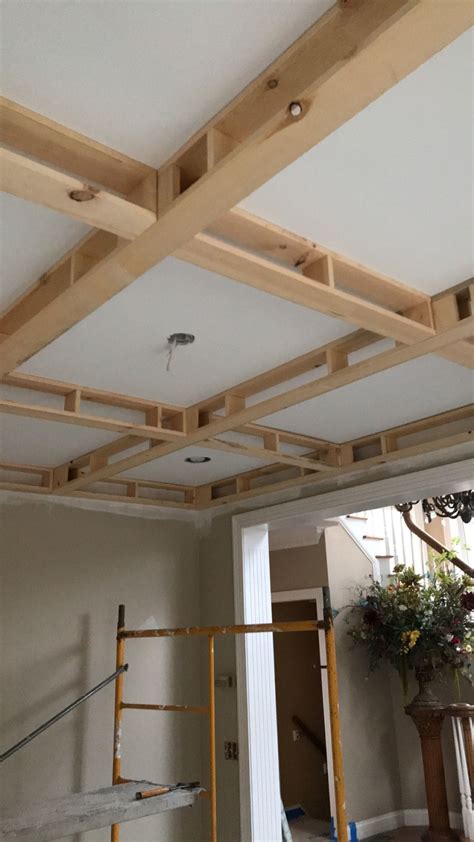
[260,356,474,442]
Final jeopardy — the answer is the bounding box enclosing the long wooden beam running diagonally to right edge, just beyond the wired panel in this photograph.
[49,316,474,494]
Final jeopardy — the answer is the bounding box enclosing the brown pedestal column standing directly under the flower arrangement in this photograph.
[405,692,459,842]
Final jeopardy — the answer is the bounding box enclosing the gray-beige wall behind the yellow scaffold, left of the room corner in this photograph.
[0,502,200,842]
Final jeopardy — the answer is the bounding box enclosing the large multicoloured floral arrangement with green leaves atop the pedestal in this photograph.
[349,554,474,693]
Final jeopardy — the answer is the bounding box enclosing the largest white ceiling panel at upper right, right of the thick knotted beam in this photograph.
[242,32,473,293]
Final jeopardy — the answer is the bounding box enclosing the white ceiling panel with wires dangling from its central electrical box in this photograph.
[21,253,350,405]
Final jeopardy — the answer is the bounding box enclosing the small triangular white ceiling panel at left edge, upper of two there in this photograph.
[0,193,90,310]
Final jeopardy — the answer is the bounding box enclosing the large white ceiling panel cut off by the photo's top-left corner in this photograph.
[1,0,333,166]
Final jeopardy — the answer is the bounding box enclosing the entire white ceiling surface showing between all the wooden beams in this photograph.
[0,0,473,484]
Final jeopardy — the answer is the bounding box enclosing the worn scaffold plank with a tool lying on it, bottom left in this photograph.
[0,781,202,842]
